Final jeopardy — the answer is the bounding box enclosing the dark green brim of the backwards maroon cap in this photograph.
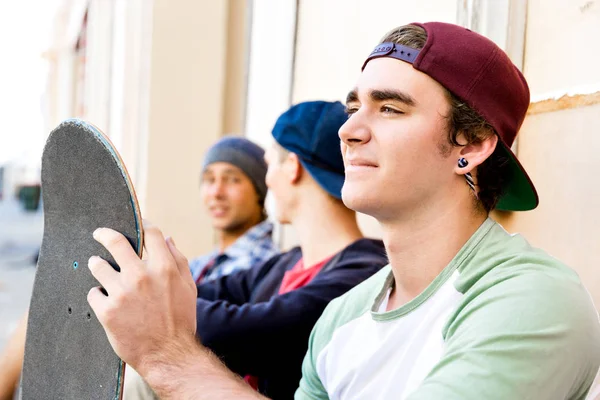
[496,139,539,211]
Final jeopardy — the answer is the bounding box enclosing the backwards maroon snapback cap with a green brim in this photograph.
[362,22,539,211]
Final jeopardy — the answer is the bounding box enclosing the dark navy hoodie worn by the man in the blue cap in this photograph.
[196,239,388,399]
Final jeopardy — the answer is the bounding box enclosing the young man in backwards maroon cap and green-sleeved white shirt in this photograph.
[88,23,600,400]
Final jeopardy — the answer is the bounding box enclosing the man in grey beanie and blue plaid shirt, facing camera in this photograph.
[190,136,279,283]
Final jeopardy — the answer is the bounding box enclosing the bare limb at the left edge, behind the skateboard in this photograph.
[0,315,27,400]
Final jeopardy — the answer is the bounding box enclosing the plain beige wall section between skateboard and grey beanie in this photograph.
[143,0,228,256]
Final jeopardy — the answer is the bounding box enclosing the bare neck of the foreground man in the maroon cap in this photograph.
[382,198,487,310]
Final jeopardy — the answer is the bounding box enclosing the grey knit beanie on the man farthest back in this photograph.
[202,136,267,202]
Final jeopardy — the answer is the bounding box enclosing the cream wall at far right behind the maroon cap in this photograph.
[503,0,600,308]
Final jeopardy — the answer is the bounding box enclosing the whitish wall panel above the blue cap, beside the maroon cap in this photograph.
[292,0,457,103]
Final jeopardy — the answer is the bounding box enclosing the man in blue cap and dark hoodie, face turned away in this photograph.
[120,101,387,400]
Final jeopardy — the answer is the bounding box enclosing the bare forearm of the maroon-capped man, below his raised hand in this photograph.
[141,338,264,400]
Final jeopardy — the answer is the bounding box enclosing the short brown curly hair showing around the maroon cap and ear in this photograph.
[380,25,508,213]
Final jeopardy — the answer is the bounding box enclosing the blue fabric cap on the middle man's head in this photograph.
[273,101,348,199]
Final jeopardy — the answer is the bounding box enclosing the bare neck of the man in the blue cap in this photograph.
[292,191,363,268]
